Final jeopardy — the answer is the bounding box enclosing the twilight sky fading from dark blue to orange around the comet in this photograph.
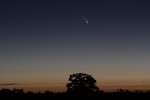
[0,0,150,91]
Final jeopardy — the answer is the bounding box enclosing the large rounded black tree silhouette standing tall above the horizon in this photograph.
[66,73,100,95]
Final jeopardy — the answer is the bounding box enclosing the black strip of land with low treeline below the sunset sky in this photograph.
[0,89,150,100]
